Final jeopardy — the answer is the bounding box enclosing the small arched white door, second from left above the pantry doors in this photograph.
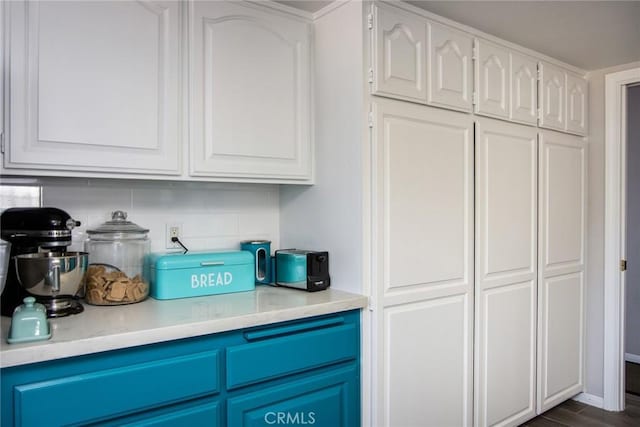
[427,22,473,111]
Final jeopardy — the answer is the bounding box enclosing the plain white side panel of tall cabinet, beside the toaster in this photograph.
[280,1,365,293]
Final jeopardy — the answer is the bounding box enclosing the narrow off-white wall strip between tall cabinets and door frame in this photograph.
[585,62,640,397]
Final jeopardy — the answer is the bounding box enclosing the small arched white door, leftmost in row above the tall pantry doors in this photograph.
[371,3,427,103]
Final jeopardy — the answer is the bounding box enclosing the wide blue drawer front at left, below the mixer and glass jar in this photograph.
[14,350,220,426]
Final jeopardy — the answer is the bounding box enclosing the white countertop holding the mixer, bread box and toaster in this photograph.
[0,286,367,368]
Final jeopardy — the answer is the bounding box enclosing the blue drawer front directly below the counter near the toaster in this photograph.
[227,315,360,390]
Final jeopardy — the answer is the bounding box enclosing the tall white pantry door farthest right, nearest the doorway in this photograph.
[537,131,586,413]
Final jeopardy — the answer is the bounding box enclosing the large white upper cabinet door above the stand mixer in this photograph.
[4,1,183,175]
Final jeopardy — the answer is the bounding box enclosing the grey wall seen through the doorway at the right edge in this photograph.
[625,86,640,362]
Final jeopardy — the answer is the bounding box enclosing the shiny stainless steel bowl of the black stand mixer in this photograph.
[14,252,89,296]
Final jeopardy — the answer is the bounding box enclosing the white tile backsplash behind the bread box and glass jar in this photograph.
[2,178,280,252]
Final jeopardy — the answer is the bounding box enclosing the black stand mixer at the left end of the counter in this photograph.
[0,208,86,317]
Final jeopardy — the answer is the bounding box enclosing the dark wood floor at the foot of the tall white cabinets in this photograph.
[523,393,640,427]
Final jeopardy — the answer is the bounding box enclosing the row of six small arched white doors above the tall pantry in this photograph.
[368,2,588,135]
